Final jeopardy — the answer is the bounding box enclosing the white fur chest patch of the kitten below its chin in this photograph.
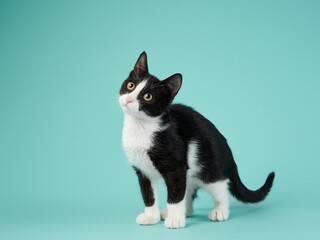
[122,115,161,178]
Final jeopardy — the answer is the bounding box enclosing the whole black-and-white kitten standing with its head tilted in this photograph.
[119,52,275,228]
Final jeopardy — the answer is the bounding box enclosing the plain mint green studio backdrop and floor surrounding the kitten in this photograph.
[0,0,320,240]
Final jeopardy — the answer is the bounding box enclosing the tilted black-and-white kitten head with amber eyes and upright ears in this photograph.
[119,52,182,117]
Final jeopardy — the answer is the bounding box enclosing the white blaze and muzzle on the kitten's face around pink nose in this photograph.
[119,80,147,113]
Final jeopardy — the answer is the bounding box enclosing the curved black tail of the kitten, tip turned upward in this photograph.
[229,168,275,203]
